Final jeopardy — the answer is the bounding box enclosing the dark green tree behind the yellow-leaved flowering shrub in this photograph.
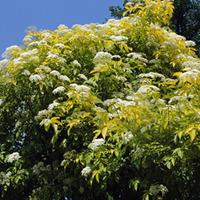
[109,0,200,52]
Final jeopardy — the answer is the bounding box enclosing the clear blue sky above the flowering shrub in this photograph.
[0,0,123,54]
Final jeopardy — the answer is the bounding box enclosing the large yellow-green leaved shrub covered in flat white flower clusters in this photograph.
[0,0,200,200]
